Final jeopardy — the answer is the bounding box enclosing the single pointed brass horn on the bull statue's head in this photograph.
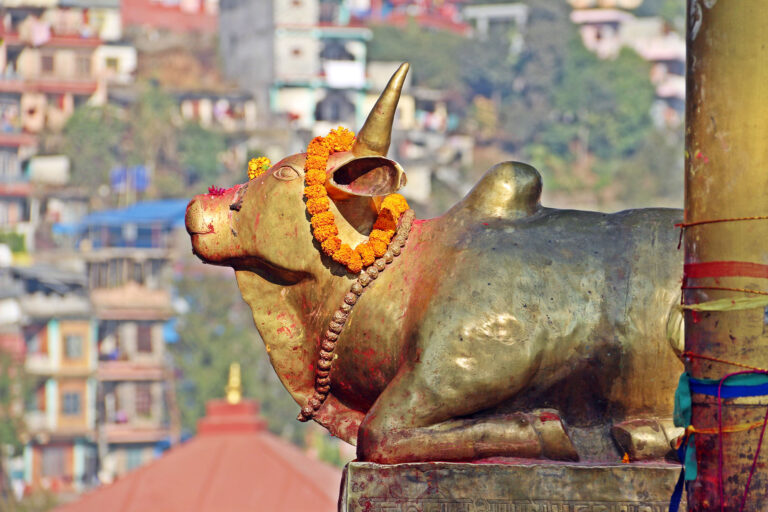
[352,62,411,156]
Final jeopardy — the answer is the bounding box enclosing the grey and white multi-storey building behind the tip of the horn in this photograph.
[219,0,371,131]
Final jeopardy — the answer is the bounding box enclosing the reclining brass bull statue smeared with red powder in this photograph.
[186,64,682,463]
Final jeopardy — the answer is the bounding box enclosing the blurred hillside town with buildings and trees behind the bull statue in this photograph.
[0,0,685,510]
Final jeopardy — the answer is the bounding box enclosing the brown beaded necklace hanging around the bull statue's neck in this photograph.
[296,210,414,421]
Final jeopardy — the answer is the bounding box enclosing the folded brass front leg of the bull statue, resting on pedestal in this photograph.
[357,344,578,463]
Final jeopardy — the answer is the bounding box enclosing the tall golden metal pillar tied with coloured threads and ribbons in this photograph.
[684,0,768,511]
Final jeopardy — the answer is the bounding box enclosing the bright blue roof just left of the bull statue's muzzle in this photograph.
[60,199,189,231]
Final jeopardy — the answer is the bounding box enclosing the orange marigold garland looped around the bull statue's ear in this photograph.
[304,127,408,274]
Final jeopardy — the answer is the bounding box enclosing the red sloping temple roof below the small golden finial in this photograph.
[55,400,341,512]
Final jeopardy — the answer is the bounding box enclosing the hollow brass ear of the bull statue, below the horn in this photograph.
[326,156,406,199]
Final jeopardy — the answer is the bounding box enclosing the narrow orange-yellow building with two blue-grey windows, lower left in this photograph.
[11,266,97,491]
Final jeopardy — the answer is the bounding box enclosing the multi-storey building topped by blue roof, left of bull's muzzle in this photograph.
[72,200,186,480]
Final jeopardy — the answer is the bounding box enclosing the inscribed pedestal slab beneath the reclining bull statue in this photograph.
[339,462,685,512]
